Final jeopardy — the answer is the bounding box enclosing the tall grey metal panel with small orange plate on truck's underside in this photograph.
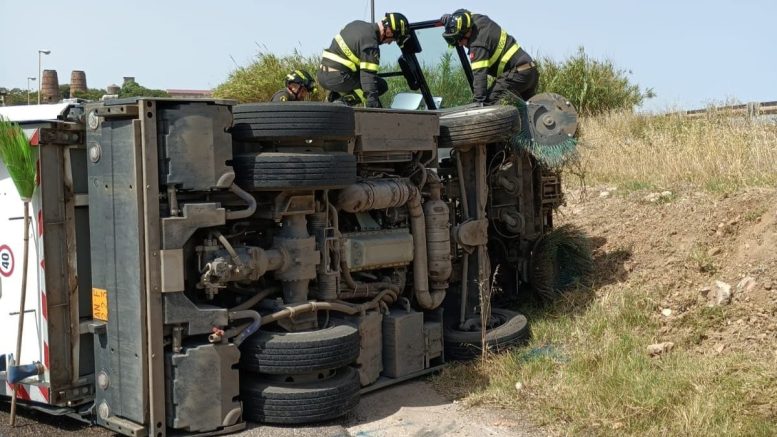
[87,109,148,426]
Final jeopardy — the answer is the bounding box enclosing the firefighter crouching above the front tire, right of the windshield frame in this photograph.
[440,9,539,105]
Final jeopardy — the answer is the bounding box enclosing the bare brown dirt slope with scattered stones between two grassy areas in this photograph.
[558,187,777,359]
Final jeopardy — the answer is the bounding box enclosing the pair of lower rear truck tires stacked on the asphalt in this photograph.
[240,324,361,424]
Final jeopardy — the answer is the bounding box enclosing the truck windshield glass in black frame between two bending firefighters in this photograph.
[380,27,472,109]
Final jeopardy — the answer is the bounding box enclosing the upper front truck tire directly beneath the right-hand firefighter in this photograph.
[439,105,521,147]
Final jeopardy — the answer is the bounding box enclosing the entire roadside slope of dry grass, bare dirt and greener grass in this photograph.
[434,111,777,436]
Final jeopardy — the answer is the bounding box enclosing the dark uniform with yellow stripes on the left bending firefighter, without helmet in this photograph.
[316,21,388,108]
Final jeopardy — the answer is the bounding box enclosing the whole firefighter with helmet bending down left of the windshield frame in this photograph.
[316,12,410,108]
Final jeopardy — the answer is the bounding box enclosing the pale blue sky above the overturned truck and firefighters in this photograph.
[0,0,777,111]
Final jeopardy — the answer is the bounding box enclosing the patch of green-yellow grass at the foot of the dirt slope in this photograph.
[433,289,777,436]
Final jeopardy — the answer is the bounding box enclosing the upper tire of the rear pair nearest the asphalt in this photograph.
[240,325,359,375]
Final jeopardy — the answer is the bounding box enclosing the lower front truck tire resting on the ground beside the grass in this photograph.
[443,308,529,360]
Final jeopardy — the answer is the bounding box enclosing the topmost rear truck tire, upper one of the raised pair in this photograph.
[231,102,356,142]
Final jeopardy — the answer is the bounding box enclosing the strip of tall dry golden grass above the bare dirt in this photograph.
[580,113,777,192]
